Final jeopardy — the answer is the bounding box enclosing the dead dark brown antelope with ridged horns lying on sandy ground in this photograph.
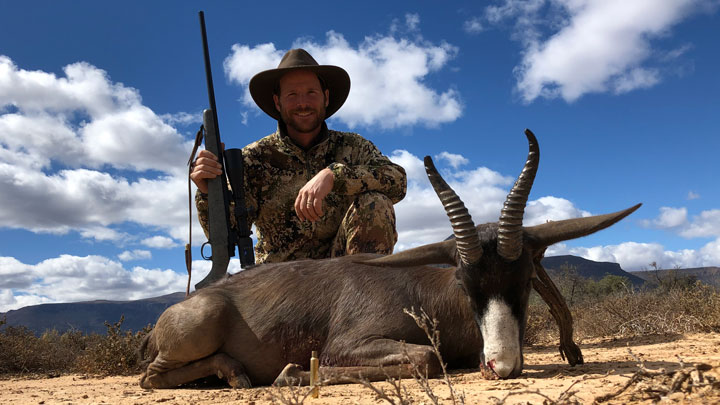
[140,130,640,388]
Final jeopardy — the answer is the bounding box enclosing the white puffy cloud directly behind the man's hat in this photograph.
[224,14,462,128]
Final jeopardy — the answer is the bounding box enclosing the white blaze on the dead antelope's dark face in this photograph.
[478,298,522,378]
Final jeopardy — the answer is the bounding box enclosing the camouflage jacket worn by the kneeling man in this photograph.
[196,124,407,263]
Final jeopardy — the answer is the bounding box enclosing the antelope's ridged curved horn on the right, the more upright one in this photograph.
[497,129,540,261]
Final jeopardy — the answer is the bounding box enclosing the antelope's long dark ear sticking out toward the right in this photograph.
[523,204,642,249]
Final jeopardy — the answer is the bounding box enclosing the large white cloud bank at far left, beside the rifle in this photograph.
[0,56,202,243]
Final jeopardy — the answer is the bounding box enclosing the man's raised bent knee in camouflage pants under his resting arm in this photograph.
[330,191,397,257]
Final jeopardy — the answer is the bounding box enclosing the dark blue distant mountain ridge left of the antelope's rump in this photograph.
[0,292,185,335]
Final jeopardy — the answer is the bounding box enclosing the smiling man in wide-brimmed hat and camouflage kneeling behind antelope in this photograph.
[190,49,407,263]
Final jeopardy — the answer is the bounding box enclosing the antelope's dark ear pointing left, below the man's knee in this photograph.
[358,239,457,267]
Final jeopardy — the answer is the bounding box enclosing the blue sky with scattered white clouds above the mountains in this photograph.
[0,0,720,311]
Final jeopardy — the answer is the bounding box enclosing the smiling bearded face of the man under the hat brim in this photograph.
[273,70,329,134]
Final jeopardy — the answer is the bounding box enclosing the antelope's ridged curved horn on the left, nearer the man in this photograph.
[425,156,482,265]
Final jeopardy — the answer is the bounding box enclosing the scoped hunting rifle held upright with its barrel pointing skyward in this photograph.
[195,11,255,289]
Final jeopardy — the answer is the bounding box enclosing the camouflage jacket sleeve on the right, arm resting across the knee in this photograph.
[328,134,407,204]
